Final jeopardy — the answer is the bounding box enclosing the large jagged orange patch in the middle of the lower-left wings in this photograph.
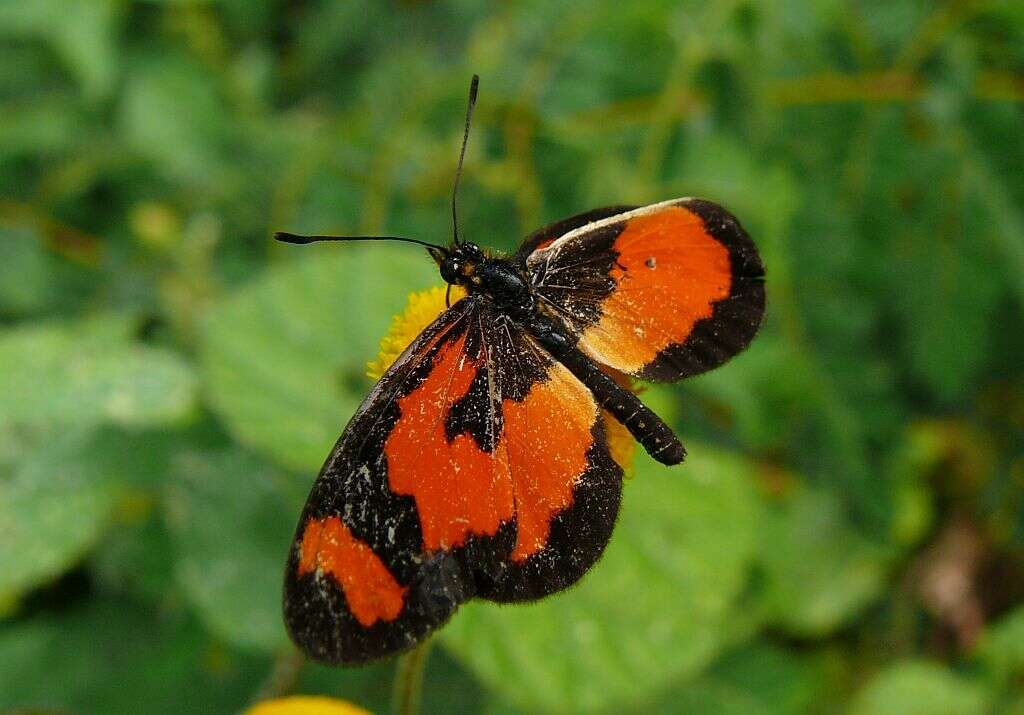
[384,327,597,560]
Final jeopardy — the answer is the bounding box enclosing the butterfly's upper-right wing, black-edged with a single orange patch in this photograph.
[526,199,765,381]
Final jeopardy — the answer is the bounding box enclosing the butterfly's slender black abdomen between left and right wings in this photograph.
[529,316,686,465]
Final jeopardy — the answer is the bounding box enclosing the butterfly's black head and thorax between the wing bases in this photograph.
[438,243,535,316]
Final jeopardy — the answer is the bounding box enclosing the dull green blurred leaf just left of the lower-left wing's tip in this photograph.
[164,449,305,651]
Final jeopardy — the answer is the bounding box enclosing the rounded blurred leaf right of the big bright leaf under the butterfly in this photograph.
[759,490,889,636]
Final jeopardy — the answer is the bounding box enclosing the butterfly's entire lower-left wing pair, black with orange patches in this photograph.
[285,298,622,663]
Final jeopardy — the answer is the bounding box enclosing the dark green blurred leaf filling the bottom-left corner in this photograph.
[0,599,267,715]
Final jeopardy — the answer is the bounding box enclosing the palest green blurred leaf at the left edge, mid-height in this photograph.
[0,316,197,432]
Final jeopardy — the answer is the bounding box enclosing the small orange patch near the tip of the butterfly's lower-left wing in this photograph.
[299,516,408,628]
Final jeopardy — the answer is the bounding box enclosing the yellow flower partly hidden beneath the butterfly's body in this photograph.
[367,286,636,477]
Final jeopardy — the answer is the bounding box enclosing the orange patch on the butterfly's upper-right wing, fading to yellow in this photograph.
[580,206,732,373]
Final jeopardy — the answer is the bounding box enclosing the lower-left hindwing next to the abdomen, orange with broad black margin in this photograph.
[478,331,623,601]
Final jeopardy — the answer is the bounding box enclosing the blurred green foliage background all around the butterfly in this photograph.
[0,0,1024,715]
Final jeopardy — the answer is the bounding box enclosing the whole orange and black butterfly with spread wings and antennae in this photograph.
[278,77,765,664]
